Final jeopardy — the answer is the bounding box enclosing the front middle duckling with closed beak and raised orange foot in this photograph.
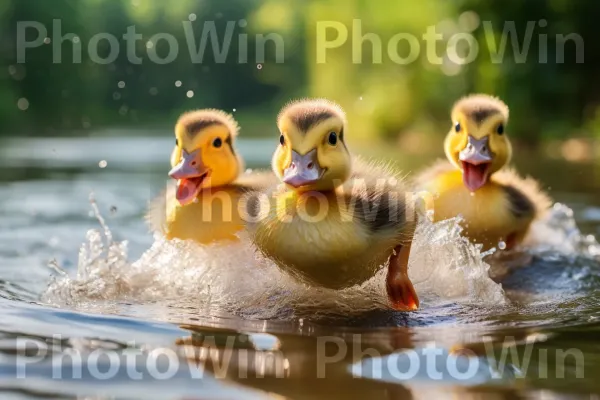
[250,100,419,310]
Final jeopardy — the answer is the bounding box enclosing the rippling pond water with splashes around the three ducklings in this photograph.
[0,132,600,399]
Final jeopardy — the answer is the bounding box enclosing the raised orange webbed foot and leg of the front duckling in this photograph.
[386,243,419,311]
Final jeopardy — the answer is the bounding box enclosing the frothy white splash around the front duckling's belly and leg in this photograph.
[43,195,505,319]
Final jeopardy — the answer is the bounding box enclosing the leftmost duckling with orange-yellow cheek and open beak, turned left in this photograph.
[146,109,276,244]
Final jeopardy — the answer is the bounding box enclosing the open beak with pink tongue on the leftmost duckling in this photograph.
[169,149,210,205]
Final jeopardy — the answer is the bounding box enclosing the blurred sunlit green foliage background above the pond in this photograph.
[0,0,600,161]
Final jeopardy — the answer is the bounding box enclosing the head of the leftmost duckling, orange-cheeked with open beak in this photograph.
[169,110,243,205]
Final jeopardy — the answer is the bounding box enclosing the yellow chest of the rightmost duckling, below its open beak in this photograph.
[426,170,530,248]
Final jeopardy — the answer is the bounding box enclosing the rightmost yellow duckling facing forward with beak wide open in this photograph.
[415,94,550,249]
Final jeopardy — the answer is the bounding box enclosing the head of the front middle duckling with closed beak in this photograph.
[272,99,352,192]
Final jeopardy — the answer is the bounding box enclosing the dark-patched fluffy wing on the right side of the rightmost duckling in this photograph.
[493,168,552,219]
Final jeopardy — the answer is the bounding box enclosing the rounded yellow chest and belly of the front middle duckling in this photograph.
[254,191,390,288]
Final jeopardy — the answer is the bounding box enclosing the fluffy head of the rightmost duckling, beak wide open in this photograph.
[444,94,512,192]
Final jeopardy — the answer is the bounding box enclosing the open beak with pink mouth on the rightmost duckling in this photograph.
[458,135,494,192]
